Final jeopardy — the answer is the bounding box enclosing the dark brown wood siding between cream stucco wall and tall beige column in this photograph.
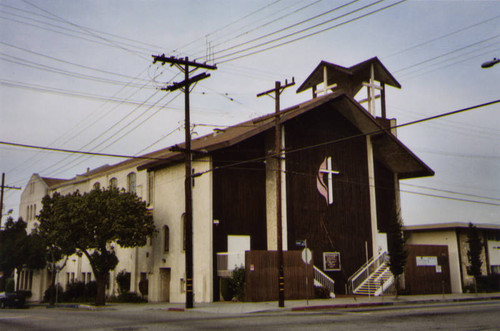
[213,135,267,300]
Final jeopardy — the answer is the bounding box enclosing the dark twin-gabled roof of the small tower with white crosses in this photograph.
[297,57,401,97]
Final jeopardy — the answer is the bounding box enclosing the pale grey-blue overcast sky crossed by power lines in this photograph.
[0,0,500,225]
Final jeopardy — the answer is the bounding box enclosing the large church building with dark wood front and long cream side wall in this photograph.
[18,58,434,302]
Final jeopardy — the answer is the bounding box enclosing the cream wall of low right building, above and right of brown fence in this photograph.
[406,230,462,293]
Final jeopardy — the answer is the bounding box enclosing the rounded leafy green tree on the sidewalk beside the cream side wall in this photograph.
[38,187,155,306]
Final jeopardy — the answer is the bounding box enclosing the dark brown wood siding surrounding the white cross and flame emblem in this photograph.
[285,105,372,293]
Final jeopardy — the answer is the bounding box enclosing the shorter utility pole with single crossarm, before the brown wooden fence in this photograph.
[257,78,295,308]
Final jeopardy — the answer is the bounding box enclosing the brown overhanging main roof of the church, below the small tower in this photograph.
[138,90,434,179]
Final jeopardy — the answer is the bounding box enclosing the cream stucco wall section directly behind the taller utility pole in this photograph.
[149,157,213,302]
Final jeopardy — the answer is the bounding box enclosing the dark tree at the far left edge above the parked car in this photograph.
[0,217,46,291]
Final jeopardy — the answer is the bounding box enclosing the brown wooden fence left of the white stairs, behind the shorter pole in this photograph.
[245,251,314,301]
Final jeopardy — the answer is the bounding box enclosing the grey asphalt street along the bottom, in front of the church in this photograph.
[0,300,500,331]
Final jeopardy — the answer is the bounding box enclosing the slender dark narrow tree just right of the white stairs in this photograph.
[387,207,408,297]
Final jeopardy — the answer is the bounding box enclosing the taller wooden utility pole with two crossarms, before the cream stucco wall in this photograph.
[153,54,217,308]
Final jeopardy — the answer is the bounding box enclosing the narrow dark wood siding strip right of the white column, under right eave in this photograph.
[375,161,396,233]
